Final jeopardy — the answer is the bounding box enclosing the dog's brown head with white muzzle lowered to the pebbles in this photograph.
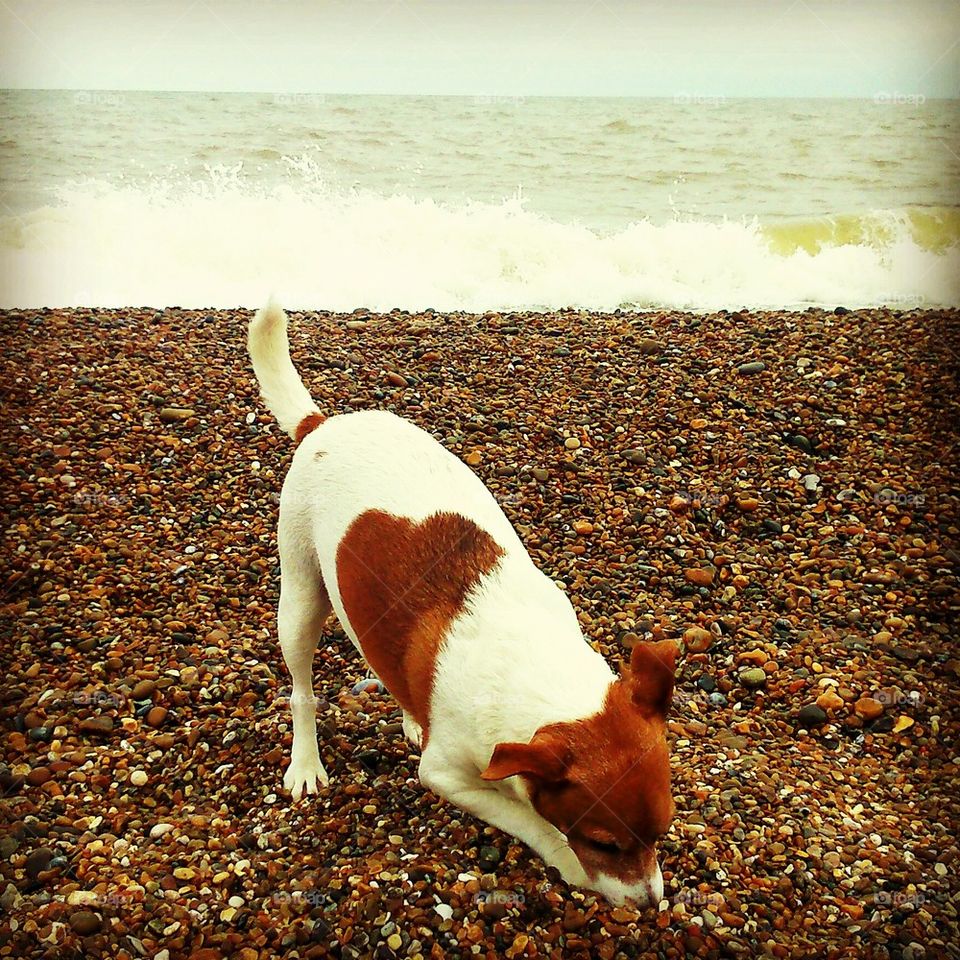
[482,640,677,904]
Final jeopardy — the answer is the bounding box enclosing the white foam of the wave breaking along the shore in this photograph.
[0,176,960,310]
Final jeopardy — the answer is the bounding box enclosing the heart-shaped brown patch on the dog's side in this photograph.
[337,510,503,744]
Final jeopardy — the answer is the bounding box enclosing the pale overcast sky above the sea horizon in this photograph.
[0,0,960,97]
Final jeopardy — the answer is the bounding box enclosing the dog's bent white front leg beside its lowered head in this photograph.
[420,763,590,887]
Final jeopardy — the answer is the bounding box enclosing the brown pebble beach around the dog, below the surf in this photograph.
[0,307,960,960]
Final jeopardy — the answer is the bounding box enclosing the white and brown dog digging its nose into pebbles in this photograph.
[248,303,677,904]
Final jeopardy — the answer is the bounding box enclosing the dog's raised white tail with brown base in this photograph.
[247,299,324,443]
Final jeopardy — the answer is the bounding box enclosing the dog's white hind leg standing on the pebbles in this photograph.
[277,517,331,800]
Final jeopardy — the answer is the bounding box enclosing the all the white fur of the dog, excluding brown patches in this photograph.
[250,304,662,902]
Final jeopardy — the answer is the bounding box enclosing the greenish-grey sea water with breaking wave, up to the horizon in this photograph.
[0,91,960,311]
